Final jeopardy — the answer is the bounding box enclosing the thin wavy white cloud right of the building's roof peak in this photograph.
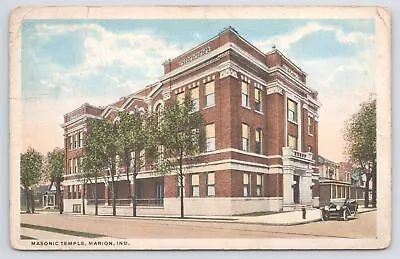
[253,22,372,51]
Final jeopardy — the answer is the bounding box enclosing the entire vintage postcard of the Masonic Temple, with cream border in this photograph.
[9,6,391,250]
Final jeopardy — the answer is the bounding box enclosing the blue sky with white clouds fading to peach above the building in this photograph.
[22,19,375,160]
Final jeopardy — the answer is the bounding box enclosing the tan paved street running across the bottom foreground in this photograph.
[21,211,376,239]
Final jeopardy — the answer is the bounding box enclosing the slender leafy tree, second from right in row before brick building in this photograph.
[118,110,153,217]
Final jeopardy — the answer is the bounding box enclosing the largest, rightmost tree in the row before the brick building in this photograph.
[154,99,205,218]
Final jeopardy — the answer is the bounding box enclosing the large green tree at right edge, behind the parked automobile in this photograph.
[344,97,377,208]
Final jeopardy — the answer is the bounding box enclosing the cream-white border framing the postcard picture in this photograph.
[9,6,391,250]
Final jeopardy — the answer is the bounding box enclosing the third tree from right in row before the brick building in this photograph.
[84,119,118,216]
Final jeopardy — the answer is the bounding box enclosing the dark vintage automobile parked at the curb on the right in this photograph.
[321,199,358,221]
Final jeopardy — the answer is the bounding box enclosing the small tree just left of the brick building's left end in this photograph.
[45,147,65,214]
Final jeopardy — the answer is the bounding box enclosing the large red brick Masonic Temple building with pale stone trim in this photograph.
[62,27,320,215]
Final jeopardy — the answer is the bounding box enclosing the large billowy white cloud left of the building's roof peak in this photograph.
[32,24,188,98]
